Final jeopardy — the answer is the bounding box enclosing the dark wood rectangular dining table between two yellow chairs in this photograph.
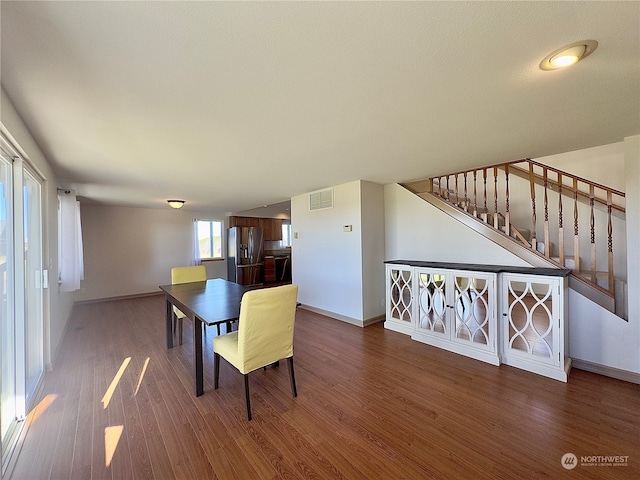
[160,278,251,397]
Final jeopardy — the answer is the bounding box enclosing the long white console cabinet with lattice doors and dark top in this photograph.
[385,261,571,382]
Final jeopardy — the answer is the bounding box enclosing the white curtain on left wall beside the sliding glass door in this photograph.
[60,191,84,292]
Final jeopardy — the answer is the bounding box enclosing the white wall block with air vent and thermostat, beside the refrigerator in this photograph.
[291,181,384,323]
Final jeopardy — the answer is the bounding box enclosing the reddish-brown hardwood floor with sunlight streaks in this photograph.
[10,296,640,480]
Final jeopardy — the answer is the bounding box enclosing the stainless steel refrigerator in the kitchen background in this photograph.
[227,227,264,285]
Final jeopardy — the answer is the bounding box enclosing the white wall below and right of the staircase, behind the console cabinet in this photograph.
[385,140,640,374]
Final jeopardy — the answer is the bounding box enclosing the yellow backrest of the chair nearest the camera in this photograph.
[238,285,298,373]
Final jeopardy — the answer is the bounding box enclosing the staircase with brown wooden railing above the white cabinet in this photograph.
[402,159,627,320]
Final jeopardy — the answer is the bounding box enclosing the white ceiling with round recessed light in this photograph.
[0,0,640,212]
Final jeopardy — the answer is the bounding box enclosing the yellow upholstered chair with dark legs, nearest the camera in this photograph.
[213,285,298,420]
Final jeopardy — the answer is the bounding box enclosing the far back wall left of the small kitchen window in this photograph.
[75,205,227,300]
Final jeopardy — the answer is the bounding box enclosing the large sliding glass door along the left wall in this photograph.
[0,139,44,472]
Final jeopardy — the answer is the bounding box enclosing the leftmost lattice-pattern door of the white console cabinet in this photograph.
[384,265,413,335]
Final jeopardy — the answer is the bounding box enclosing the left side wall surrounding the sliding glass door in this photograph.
[0,89,73,368]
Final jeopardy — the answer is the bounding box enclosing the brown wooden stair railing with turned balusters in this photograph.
[403,159,625,320]
